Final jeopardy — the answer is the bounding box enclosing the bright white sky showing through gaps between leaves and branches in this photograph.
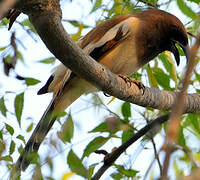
[0,0,199,179]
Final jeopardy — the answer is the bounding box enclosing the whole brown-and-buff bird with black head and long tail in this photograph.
[15,9,189,171]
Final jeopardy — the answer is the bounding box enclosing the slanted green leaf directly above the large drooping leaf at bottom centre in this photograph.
[82,136,109,159]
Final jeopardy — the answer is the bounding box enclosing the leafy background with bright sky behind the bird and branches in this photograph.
[0,0,200,179]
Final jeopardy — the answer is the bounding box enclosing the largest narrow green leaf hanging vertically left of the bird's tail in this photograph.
[15,92,24,126]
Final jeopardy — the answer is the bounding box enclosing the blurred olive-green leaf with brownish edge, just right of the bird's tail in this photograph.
[58,114,74,143]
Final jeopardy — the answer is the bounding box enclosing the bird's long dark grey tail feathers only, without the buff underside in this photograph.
[15,97,57,172]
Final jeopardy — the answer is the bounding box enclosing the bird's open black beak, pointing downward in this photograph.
[170,42,189,65]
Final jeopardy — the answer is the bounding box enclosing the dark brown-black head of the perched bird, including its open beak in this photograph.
[136,9,189,65]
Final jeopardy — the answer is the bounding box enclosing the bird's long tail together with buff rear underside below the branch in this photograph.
[15,78,97,173]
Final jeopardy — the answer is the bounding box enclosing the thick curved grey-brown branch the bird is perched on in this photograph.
[14,0,200,112]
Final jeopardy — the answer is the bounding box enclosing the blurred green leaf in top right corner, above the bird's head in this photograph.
[177,0,197,19]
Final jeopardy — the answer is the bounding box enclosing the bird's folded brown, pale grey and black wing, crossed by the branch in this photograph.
[38,15,133,95]
